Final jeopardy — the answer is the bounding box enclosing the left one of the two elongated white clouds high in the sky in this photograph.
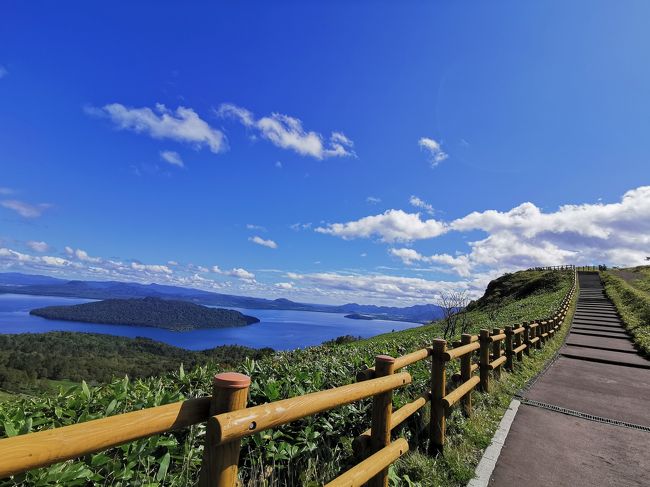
[86,103,226,153]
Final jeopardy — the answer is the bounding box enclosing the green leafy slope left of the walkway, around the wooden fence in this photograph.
[0,272,570,486]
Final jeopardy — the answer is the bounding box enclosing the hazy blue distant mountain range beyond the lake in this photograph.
[0,272,442,323]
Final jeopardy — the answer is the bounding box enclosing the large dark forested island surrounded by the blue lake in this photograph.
[30,297,260,331]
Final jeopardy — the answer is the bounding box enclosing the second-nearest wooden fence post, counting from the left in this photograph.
[368,355,395,487]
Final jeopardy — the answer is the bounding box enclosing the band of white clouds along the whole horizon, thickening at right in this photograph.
[0,186,650,305]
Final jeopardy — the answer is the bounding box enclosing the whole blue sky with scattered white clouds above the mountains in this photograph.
[0,1,650,305]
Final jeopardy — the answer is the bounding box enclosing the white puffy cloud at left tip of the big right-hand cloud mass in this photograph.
[316,210,447,242]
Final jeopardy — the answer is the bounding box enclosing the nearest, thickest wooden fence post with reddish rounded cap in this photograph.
[199,372,251,487]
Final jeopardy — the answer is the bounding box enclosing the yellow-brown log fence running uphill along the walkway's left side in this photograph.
[0,272,576,487]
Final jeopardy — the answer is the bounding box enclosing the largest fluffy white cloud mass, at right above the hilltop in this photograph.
[326,186,650,277]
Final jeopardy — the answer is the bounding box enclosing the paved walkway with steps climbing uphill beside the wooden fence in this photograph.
[490,272,650,487]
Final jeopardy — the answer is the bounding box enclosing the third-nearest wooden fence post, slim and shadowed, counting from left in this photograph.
[429,338,447,455]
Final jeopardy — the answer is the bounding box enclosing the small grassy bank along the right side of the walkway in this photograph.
[601,266,650,356]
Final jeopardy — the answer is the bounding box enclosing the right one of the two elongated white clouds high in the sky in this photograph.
[217,103,355,159]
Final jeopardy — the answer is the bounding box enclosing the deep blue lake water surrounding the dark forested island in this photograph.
[0,294,420,350]
